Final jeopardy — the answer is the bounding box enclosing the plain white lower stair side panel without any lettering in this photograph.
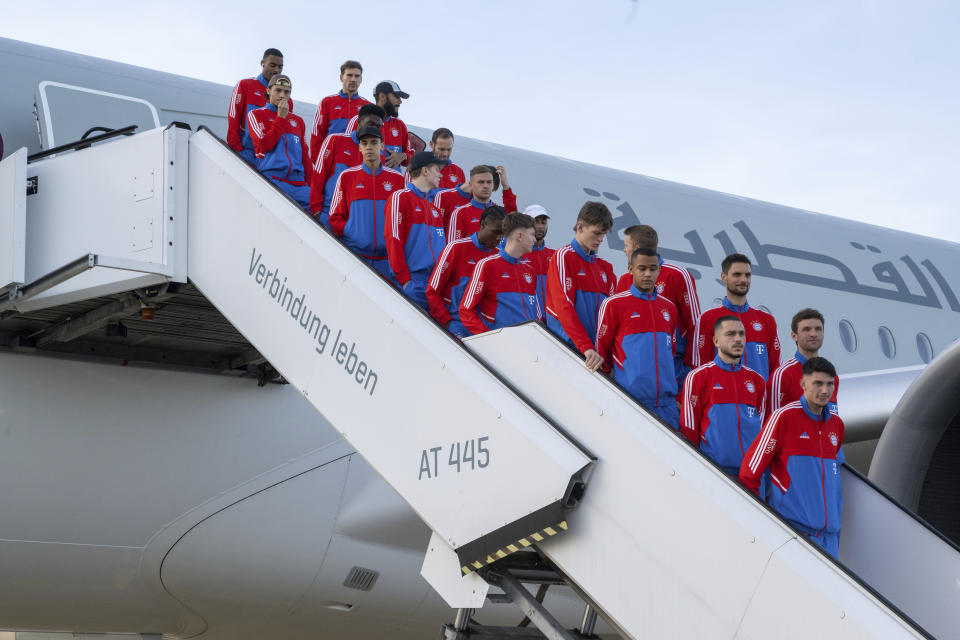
[465,324,921,639]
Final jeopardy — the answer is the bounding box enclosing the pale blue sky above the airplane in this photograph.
[0,0,960,242]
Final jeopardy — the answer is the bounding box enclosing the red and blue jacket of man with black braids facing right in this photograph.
[427,233,497,332]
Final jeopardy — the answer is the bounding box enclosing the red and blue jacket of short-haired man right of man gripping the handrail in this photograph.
[597,286,679,429]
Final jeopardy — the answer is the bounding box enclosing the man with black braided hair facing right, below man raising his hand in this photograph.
[427,206,507,338]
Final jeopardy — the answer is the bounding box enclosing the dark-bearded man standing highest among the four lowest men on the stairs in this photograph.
[686,253,780,381]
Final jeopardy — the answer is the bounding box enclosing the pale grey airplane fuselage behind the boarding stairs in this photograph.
[0,39,960,638]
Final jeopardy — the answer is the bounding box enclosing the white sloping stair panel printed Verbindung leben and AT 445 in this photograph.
[189,132,590,548]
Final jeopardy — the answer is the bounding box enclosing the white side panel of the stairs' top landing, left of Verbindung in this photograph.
[18,129,189,311]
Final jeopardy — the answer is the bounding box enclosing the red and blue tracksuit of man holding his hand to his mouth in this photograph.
[247,104,313,206]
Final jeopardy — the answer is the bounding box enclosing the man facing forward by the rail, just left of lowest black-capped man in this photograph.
[330,127,403,281]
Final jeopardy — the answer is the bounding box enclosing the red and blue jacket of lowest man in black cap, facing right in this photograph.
[384,182,447,286]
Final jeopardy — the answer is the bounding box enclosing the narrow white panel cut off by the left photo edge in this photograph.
[0,149,27,289]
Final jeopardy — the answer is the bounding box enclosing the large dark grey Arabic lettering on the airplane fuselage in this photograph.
[585,190,960,312]
